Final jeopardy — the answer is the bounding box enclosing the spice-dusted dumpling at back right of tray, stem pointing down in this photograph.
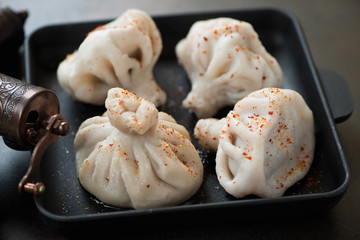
[176,18,283,118]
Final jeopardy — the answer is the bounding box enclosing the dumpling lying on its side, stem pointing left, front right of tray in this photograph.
[195,88,315,198]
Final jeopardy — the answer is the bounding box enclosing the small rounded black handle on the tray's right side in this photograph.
[318,70,354,123]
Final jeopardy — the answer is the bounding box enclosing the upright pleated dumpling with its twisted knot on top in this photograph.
[74,88,203,209]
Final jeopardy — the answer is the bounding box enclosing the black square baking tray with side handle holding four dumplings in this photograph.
[21,9,352,223]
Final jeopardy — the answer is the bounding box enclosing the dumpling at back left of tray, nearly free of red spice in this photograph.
[57,9,166,106]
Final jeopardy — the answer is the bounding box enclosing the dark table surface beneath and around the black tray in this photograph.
[0,0,360,239]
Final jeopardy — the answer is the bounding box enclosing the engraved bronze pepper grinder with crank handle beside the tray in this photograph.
[0,73,70,195]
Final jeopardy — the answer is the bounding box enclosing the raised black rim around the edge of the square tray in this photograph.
[25,7,351,222]
